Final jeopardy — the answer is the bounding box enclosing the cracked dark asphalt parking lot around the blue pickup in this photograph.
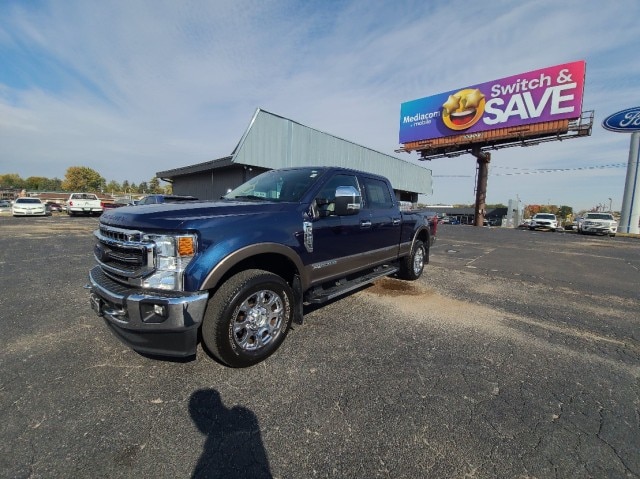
[0,215,640,479]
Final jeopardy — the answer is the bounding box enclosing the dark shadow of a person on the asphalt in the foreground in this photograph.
[189,389,273,479]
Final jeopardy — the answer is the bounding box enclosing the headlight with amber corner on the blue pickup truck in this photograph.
[142,234,197,290]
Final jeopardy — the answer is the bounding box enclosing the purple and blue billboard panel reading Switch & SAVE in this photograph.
[400,61,586,145]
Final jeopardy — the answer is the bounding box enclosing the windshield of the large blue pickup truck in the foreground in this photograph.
[223,168,325,202]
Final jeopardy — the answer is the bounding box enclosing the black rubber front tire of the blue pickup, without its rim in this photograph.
[202,270,294,368]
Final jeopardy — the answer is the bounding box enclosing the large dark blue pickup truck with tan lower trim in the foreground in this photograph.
[89,167,437,367]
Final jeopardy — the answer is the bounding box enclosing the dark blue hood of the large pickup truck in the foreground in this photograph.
[100,200,292,231]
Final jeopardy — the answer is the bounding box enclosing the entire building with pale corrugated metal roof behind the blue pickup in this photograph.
[156,109,433,203]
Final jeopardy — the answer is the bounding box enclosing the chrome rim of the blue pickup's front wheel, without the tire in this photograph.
[233,290,286,351]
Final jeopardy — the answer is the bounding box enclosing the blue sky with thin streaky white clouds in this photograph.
[0,0,640,210]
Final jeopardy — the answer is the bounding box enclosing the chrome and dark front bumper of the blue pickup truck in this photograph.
[89,266,209,357]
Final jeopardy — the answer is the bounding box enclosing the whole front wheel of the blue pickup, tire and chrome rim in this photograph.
[202,269,294,368]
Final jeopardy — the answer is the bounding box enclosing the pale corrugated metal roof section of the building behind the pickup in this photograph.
[231,109,433,194]
